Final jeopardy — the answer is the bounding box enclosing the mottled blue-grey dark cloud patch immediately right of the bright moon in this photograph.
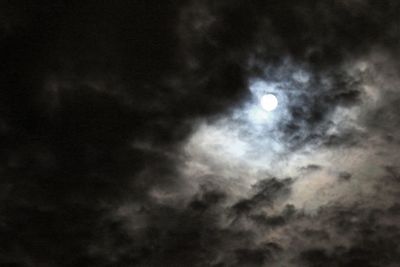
[279,69,360,149]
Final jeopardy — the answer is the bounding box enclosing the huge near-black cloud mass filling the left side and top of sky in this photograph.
[0,0,400,267]
